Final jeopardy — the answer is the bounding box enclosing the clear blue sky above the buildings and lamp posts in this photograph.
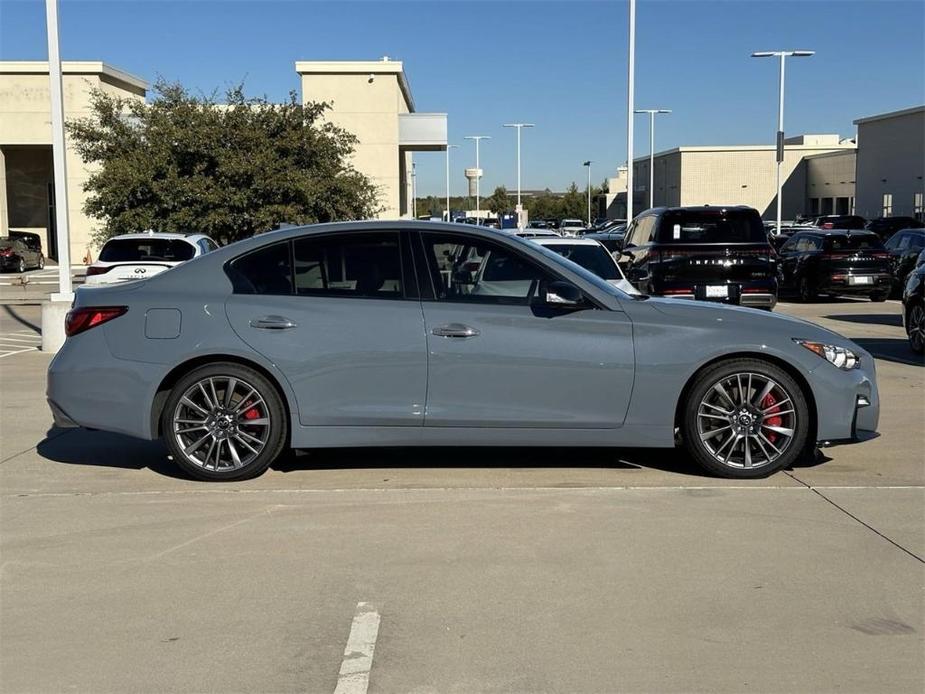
[0,0,925,195]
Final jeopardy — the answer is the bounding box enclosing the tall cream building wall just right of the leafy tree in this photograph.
[296,59,414,219]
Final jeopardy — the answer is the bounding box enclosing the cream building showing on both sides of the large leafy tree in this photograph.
[0,58,447,262]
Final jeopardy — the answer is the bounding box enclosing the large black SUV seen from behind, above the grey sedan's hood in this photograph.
[619,206,777,309]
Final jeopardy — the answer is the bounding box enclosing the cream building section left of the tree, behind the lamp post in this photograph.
[0,61,147,262]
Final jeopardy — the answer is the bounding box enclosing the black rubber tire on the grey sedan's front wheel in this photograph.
[681,358,810,479]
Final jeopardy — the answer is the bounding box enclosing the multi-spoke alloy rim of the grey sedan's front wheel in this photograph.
[697,372,798,469]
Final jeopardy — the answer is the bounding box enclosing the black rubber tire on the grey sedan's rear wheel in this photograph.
[161,362,289,482]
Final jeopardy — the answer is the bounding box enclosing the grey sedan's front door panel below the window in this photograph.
[423,301,634,428]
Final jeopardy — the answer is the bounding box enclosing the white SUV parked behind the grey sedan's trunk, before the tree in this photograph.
[85,231,218,286]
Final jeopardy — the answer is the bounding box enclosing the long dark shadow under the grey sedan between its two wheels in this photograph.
[272,446,702,477]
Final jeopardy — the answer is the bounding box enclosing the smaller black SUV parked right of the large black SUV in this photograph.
[780,229,893,301]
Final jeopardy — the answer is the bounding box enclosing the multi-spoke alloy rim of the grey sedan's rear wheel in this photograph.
[172,376,270,472]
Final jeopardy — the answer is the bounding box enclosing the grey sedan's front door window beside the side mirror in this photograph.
[421,232,547,304]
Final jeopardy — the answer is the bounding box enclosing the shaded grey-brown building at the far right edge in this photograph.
[854,106,925,219]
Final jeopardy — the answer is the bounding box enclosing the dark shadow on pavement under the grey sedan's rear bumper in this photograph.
[36,427,189,479]
